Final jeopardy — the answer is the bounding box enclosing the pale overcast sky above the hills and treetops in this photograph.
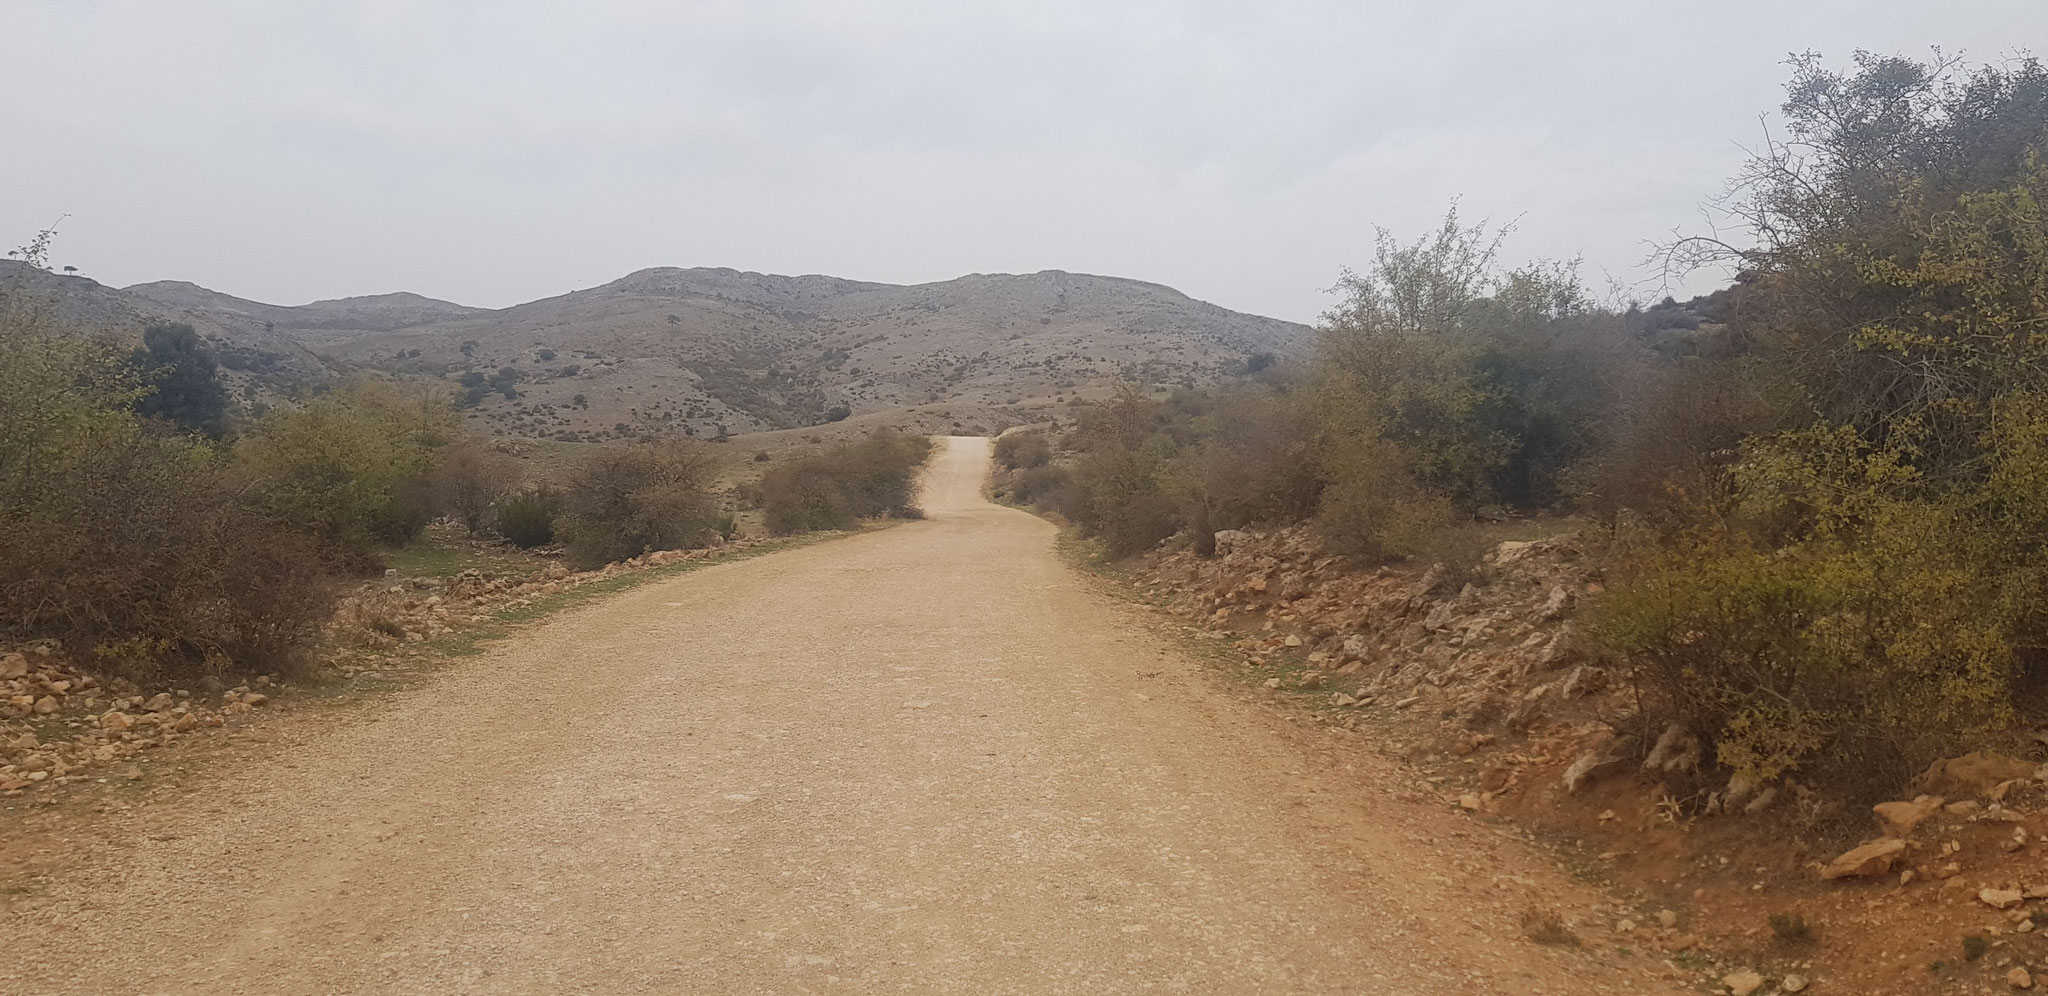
[0,0,2048,322]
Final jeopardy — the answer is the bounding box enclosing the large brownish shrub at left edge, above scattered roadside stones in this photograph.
[0,311,332,676]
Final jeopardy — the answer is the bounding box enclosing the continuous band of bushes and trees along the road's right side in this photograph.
[997,55,2048,793]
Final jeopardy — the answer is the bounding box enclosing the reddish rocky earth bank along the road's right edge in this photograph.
[1139,529,2048,994]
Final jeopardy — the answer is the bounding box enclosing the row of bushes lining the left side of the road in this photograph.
[0,234,928,682]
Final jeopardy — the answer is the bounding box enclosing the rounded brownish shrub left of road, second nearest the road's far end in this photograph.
[555,443,717,568]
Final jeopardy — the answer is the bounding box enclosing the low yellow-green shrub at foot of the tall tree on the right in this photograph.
[1593,506,2015,797]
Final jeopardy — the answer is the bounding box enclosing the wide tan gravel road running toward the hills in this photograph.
[0,439,1659,994]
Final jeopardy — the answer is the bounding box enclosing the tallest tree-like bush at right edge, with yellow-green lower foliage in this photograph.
[1595,57,2048,797]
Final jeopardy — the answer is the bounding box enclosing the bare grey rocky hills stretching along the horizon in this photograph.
[0,266,1311,439]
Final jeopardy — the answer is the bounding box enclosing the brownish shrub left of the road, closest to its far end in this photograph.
[762,432,932,535]
